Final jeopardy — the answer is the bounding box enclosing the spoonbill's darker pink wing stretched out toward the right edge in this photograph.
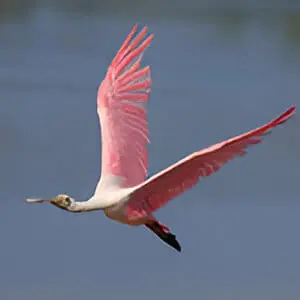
[126,107,295,219]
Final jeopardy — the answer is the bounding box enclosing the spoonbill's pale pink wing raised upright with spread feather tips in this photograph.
[96,25,154,190]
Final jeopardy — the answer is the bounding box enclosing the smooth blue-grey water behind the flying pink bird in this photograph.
[0,0,300,300]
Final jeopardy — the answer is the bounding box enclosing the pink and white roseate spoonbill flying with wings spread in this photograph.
[26,25,296,252]
